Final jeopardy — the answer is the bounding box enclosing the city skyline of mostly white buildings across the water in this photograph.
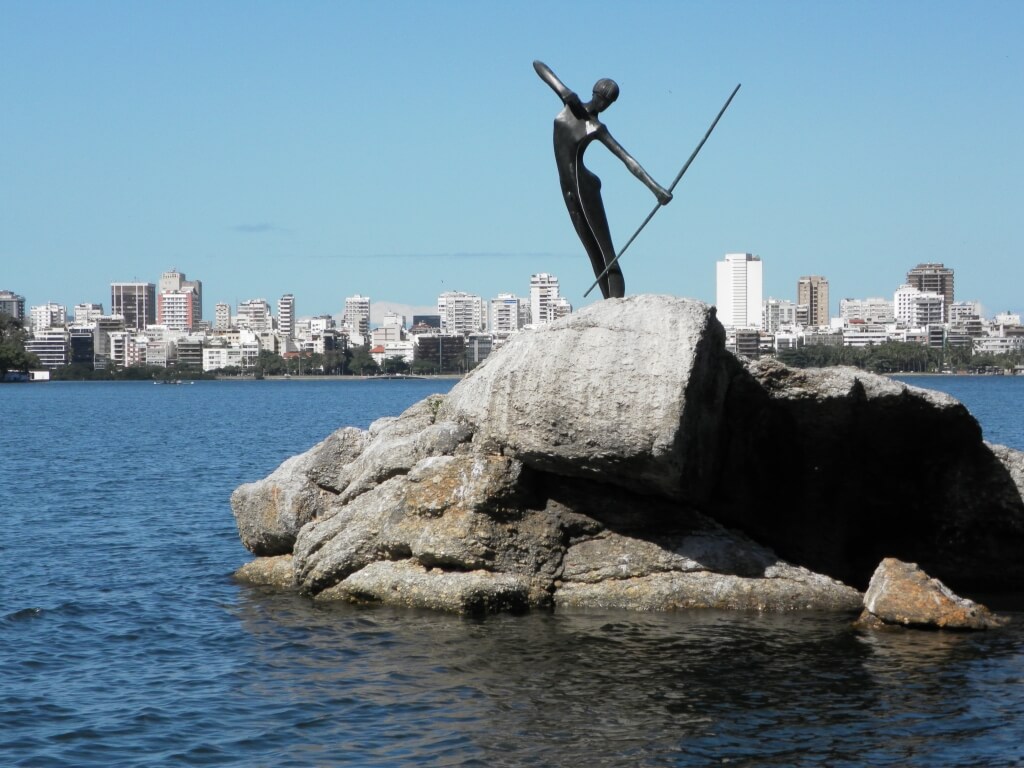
[14,259,1024,372]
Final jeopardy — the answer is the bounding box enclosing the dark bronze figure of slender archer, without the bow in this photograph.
[534,61,678,299]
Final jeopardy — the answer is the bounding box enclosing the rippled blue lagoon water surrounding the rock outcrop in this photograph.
[0,376,1024,767]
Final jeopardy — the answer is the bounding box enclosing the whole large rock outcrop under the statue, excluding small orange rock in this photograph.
[231,296,1024,612]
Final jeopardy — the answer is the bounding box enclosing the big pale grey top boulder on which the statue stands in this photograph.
[439,296,732,501]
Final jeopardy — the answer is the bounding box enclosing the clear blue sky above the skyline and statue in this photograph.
[0,0,1024,316]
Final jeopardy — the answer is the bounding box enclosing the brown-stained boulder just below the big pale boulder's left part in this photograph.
[295,455,561,603]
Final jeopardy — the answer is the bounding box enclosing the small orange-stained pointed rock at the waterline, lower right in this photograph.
[857,557,1004,630]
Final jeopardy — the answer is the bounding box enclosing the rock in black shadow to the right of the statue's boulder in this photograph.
[708,359,1024,592]
